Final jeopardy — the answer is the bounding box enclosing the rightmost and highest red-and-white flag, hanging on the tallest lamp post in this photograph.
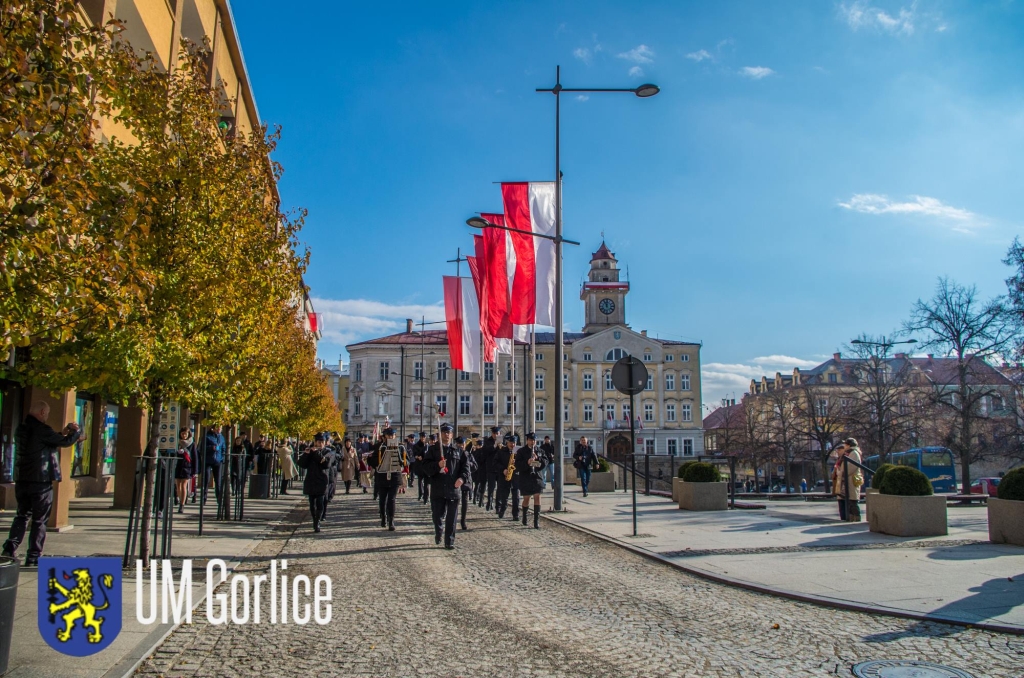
[502,181,555,339]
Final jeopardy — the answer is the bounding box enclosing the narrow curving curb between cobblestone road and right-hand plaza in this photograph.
[541,513,1024,636]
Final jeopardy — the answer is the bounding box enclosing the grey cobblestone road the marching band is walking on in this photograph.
[137,494,1024,678]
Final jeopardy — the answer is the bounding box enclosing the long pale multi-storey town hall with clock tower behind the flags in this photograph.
[345,243,703,460]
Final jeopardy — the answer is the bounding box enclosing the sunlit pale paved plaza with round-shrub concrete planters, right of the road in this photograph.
[558,486,1024,634]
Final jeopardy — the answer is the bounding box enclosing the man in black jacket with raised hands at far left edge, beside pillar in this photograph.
[3,400,81,567]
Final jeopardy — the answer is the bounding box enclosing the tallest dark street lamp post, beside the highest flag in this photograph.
[537,70,660,511]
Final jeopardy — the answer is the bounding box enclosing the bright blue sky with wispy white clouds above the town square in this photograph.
[233,0,1024,404]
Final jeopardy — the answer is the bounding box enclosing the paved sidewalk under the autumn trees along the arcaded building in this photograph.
[0,496,306,678]
